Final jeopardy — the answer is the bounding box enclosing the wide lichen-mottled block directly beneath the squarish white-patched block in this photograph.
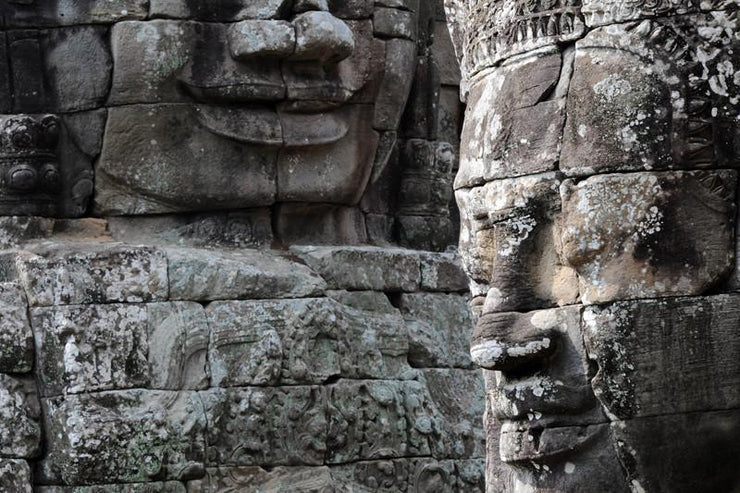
[38,390,206,484]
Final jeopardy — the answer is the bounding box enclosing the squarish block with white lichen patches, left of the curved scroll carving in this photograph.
[30,303,150,396]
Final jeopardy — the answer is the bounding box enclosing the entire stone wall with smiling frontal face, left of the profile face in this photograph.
[0,0,486,493]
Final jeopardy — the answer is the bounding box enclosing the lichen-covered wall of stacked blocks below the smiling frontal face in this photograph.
[0,240,485,492]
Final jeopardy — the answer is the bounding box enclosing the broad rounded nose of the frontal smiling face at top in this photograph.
[228,11,355,63]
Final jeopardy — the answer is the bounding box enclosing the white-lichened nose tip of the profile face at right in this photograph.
[470,313,558,371]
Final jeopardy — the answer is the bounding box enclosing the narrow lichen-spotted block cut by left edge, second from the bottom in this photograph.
[0,374,41,460]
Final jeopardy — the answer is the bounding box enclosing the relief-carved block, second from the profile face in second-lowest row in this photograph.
[326,380,443,464]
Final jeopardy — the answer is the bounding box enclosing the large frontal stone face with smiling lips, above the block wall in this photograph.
[0,0,417,215]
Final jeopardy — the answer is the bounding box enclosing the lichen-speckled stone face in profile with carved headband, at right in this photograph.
[448,0,740,492]
